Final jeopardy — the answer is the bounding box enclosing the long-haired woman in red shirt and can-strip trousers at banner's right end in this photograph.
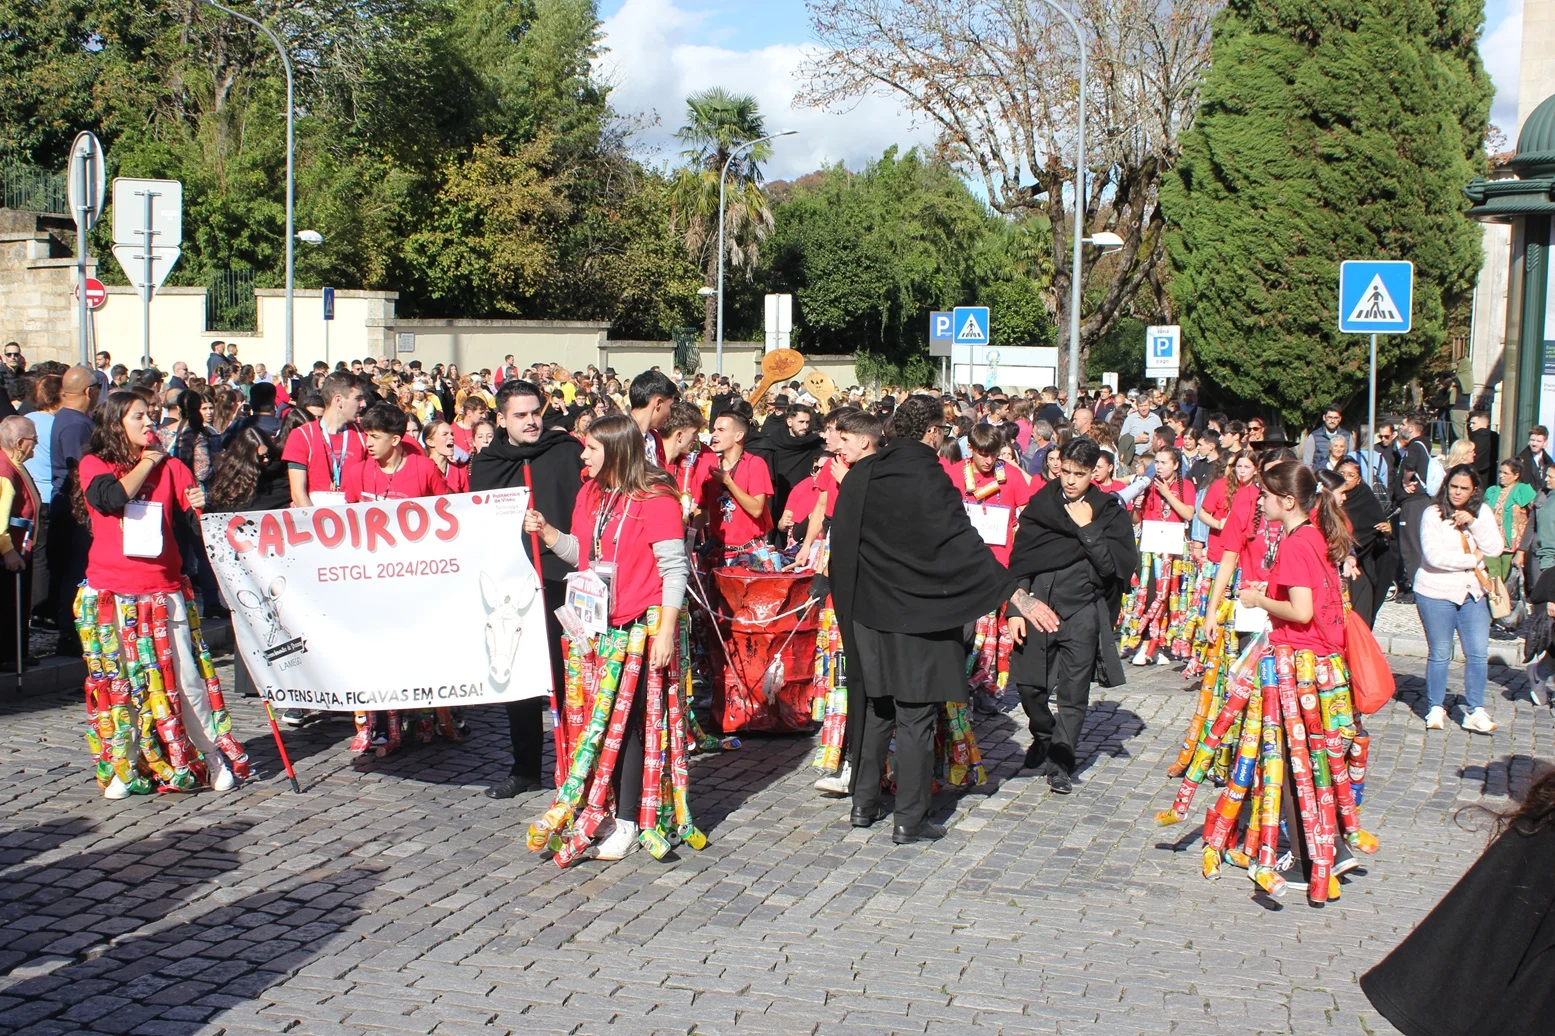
[524,414,704,866]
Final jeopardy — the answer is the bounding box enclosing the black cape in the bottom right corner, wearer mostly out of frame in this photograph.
[1361,824,1555,1036]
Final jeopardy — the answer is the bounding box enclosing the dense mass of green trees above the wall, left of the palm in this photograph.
[0,0,698,338]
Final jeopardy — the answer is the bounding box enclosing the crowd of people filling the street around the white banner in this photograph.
[0,332,1536,877]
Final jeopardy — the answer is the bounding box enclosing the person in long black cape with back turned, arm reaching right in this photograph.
[829,397,1056,843]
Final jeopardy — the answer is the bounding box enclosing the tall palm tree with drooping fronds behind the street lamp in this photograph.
[672,87,773,342]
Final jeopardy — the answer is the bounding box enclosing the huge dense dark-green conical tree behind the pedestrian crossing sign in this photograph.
[1162,0,1491,423]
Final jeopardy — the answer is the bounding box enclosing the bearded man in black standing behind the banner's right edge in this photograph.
[470,378,583,798]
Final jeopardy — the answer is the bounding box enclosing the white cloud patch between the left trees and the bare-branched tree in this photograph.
[596,0,933,179]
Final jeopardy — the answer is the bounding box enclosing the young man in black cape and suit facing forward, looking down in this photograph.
[1009,439,1140,795]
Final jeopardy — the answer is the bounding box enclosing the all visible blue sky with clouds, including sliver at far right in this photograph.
[597,0,1522,179]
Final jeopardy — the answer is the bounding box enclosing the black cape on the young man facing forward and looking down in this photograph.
[1009,479,1140,688]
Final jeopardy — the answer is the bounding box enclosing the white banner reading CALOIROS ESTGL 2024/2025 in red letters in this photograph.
[202,488,550,711]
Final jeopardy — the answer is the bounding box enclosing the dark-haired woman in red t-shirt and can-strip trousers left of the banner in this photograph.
[75,392,247,798]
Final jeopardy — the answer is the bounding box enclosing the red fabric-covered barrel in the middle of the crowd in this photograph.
[712,568,819,734]
